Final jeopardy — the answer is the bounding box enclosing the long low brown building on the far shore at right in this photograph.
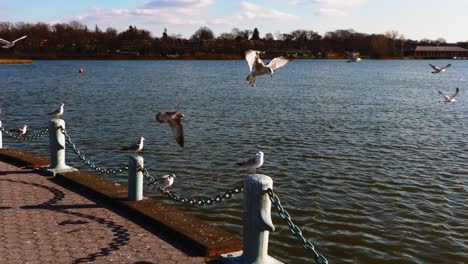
[413,46,468,59]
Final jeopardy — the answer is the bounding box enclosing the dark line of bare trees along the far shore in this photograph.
[0,21,468,59]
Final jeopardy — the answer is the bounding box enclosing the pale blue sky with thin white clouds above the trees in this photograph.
[0,0,468,42]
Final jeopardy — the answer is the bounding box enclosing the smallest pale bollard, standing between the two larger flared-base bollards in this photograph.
[128,156,144,201]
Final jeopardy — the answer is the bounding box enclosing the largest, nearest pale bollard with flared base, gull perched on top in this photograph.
[221,174,282,264]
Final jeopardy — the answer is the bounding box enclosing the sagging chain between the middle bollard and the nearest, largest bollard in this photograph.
[143,169,244,206]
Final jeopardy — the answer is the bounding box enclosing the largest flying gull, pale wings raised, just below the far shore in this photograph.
[245,50,294,87]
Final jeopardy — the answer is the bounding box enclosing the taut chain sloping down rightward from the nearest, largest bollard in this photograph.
[267,188,328,264]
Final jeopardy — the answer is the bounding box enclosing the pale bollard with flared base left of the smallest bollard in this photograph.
[42,119,77,175]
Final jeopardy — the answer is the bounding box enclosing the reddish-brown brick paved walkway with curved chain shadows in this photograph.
[0,162,206,264]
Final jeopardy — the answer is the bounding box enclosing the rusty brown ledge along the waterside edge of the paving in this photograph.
[0,148,242,257]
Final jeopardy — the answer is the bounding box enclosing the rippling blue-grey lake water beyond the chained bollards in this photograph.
[0,60,468,263]
